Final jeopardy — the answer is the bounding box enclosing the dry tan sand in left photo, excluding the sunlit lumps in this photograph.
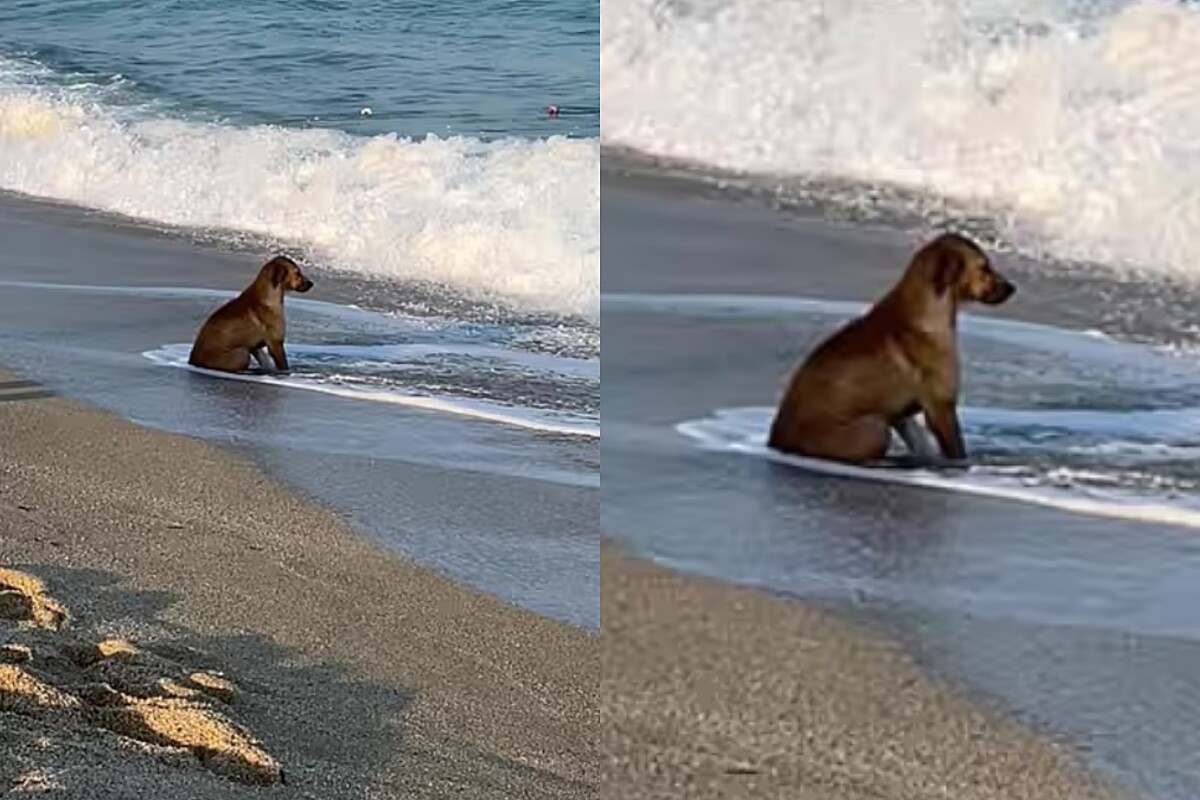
[0,375,599,799]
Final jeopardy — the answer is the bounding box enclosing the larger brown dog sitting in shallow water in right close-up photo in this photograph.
[769,234,1015,463]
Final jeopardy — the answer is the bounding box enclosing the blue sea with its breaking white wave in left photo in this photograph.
[0,1,600,319]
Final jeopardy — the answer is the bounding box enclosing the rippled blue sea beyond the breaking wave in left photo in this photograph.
[0,0,600,138]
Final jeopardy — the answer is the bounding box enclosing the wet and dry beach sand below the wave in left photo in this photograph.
[0,185,599,798]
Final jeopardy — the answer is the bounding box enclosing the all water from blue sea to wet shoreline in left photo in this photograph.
[0,0,600,627]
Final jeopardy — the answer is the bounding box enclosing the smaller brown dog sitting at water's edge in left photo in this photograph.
[187,255,312,372]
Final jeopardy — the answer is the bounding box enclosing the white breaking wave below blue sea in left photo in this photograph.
[0,59,600,319]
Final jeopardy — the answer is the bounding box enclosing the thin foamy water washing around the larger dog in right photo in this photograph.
[628,295,1200,528]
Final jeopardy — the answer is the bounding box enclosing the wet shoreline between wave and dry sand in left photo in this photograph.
[0,193,600,631]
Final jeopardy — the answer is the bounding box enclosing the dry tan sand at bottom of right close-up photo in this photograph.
[600,546,1117,800]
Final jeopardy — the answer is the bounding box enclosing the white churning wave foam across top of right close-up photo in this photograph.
[601,0,1200,278]
